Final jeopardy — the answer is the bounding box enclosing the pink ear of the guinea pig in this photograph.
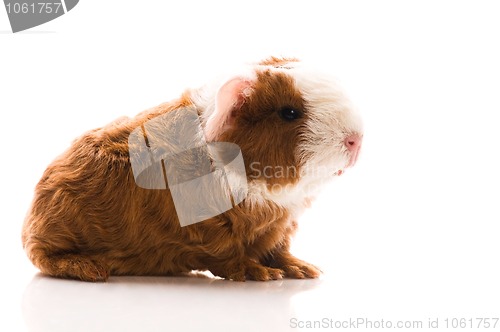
[205,77,252,142]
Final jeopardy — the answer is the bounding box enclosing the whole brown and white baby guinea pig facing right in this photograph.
[22,57,363,281]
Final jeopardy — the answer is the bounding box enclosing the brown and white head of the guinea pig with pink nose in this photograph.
[196,58,363,201]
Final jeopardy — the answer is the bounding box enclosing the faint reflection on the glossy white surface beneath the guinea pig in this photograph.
[22,274,321,332]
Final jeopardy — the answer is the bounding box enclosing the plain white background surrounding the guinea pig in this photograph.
[0,0,500,331]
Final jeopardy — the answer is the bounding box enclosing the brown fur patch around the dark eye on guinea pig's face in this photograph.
[225,71,306,186]
